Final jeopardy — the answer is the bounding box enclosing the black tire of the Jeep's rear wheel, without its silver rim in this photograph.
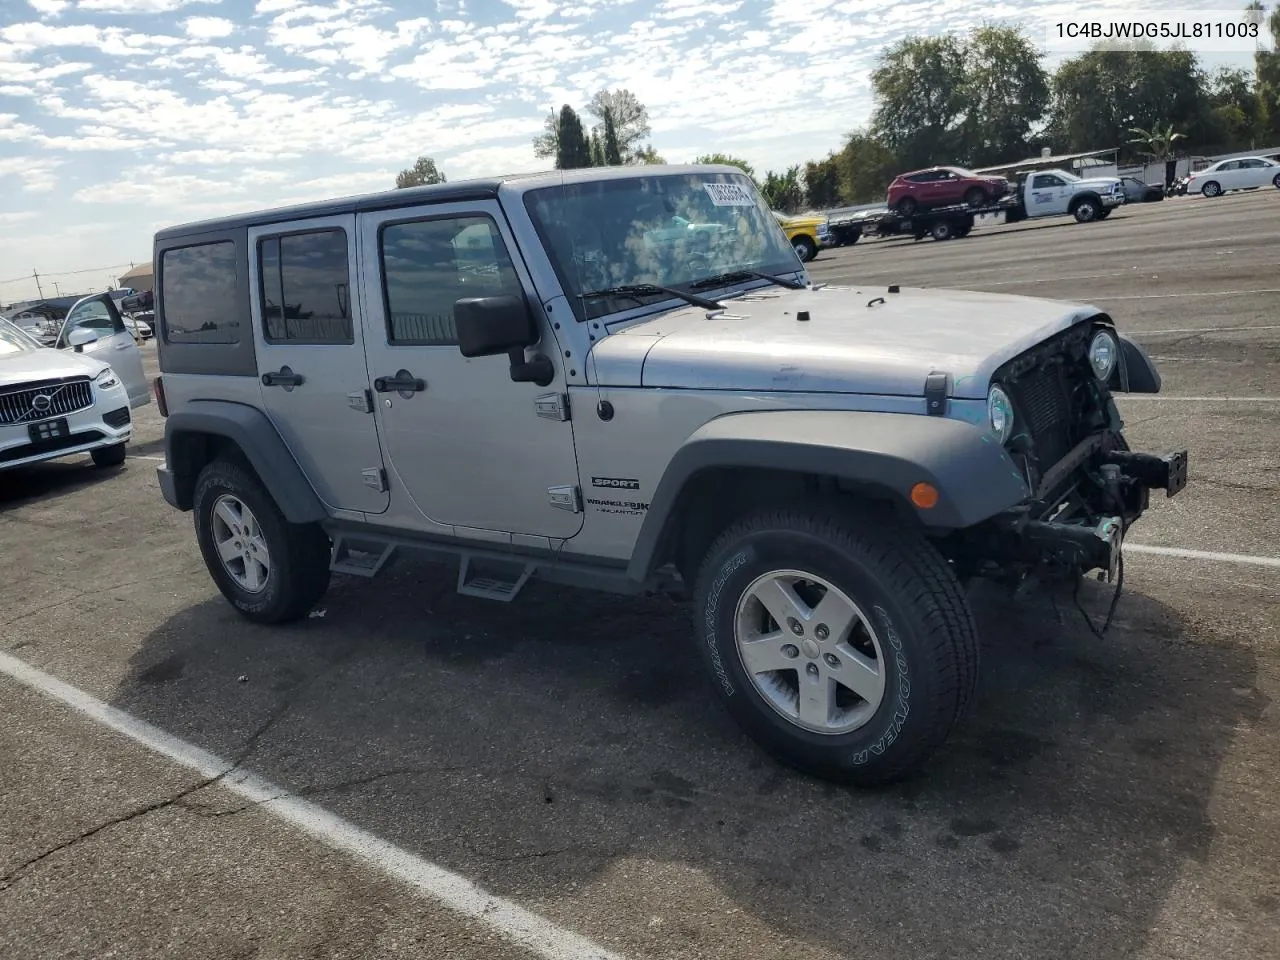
[192,460,329,623]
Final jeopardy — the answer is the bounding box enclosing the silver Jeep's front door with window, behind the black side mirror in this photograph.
[360,201,582,539]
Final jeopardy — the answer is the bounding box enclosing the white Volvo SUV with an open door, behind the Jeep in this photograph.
[0,313,147,470]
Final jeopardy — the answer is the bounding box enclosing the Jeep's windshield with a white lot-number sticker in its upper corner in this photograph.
[525,173,801,320]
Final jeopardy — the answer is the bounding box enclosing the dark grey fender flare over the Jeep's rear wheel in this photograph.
[157,401,329,524]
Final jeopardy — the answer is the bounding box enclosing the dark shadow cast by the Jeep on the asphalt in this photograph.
[114,562,1265,957]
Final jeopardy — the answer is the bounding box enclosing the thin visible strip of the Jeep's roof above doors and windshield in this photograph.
[155,164,745,242]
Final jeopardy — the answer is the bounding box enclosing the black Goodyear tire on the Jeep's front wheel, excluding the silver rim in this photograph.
[695,502,978,786]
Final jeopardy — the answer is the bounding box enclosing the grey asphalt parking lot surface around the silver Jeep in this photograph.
[0,191,1280,960]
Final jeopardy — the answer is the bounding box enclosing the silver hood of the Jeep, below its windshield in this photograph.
[588,285,1102,399]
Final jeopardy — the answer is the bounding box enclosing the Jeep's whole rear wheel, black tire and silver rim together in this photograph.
[192,460,329,623]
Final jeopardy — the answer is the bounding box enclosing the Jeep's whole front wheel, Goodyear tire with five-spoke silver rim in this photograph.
[695,504,978,786]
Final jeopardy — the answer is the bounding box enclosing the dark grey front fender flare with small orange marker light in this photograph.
[628,410,1030,579]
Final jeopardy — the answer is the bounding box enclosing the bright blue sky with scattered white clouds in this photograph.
[0,0,1249,303]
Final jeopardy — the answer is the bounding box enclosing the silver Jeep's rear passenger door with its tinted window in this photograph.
[248,214,389,513]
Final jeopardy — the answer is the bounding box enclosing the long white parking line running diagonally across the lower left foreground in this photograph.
[0,650,623,960]
